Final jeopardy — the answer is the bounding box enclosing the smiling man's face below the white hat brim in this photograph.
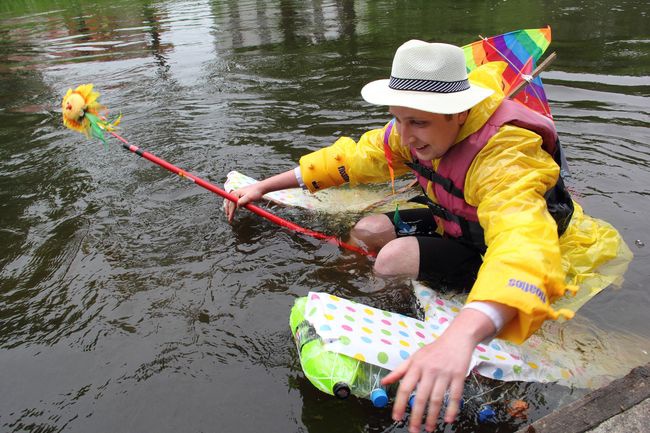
[389,106,468,161]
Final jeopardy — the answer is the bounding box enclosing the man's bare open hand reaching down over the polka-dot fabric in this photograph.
[382,310,494,433]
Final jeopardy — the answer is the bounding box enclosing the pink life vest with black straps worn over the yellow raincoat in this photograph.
[391,100,573,249]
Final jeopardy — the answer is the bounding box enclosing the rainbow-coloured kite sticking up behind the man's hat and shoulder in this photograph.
[463,26,552,118]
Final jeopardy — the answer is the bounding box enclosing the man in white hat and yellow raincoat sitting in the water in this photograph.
[224,40,629,432]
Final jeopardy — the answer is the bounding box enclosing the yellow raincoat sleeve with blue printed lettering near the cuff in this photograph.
[465,125,573,342]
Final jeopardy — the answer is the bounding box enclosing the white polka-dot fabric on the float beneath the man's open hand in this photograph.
[305,286,572,383]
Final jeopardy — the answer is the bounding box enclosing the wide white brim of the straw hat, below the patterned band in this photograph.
[361,80,494,114]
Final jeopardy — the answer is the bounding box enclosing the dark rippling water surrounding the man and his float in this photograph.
[0,0,650,432]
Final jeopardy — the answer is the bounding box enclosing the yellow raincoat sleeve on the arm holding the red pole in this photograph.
[300,120,410,192]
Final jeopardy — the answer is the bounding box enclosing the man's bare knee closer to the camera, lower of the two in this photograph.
[374,237,420,278]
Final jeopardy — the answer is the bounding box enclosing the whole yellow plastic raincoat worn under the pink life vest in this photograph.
[300,62,632,342]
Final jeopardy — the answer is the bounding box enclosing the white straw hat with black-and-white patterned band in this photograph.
[361,39,494,114]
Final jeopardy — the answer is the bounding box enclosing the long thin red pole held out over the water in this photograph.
[108,131,376,257]
